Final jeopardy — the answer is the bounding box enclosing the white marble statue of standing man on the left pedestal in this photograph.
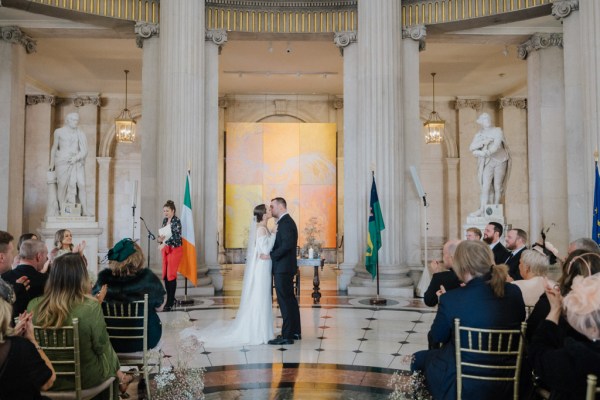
[49,113,89,216]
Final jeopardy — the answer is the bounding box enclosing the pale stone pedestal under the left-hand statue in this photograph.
[37,217,102,275]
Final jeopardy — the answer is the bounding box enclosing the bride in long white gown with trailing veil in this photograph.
[180,204,277,348]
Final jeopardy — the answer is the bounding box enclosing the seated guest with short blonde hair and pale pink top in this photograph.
[513,250,554,306]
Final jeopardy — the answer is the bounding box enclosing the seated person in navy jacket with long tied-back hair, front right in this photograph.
[411,240,525,400]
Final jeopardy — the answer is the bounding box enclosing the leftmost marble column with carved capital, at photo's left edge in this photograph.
[0,26,35,236]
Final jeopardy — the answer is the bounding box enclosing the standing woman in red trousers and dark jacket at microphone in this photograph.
[158,200,183,311]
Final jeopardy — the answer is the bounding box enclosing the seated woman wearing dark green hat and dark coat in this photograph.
[92,239,165,353]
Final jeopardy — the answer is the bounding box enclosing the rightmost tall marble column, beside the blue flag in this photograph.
[552,0,597,241]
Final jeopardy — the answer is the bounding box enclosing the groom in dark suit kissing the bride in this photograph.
[269,197,302,345]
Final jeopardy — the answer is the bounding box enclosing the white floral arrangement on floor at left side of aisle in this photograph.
[150,338,205,400]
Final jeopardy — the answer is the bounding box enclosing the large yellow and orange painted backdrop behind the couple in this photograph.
[225,123,337,248]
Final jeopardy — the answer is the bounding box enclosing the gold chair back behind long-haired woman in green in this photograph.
[33,318,81,399]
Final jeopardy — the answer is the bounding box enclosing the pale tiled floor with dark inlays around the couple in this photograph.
[122,265,435,399]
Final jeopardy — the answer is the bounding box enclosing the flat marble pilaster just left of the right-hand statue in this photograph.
[453,98,482,228]
